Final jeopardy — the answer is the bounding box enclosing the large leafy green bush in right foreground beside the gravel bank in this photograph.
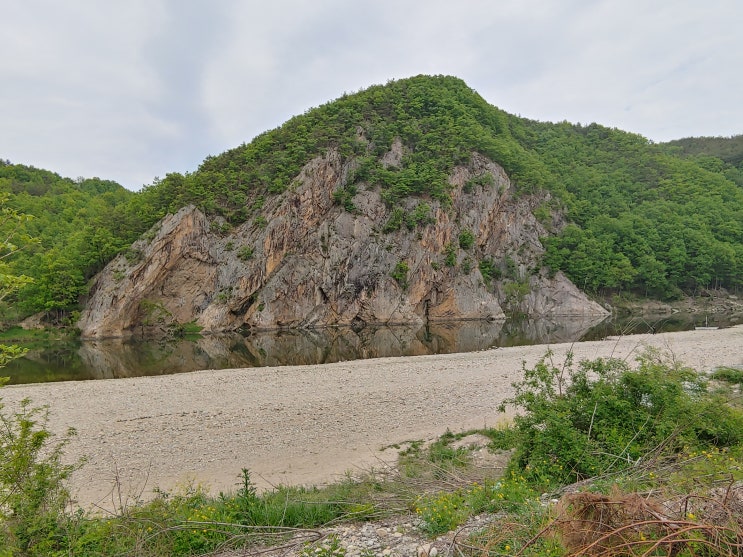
[501,352,743,486]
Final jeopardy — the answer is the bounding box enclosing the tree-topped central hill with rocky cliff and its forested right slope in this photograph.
[80,76,743,336]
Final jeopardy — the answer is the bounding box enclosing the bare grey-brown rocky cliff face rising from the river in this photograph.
[78,149,606,337]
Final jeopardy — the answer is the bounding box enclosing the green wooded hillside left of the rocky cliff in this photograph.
[0,163,143,319]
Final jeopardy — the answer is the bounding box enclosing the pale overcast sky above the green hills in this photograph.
[0,0,743,190]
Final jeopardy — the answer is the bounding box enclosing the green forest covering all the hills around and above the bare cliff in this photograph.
[0,76,743,322]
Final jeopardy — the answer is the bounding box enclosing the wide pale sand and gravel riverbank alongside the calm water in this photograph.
[0,326,743,508]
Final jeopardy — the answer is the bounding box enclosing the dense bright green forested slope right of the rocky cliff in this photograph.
[519,122,743,298]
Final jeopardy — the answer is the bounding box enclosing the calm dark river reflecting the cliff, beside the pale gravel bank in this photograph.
[2,315,731,384]
